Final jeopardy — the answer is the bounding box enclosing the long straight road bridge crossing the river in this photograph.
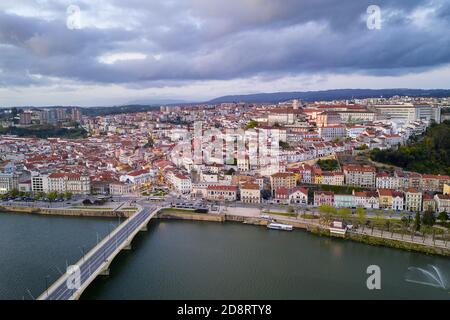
[38,206,160,300]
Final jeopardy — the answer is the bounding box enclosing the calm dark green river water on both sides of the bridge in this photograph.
[0,213,450,299]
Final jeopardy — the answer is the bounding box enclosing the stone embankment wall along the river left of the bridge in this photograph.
[0,206,134,218]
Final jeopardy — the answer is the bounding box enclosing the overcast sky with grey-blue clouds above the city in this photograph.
[0,0,450,106]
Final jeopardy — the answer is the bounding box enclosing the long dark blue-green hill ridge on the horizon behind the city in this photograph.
[208,89,450,104]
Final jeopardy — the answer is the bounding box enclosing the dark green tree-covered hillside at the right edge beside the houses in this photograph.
[370,121,450,175]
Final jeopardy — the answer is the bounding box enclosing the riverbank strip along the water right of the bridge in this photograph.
[157,209,450,257]
